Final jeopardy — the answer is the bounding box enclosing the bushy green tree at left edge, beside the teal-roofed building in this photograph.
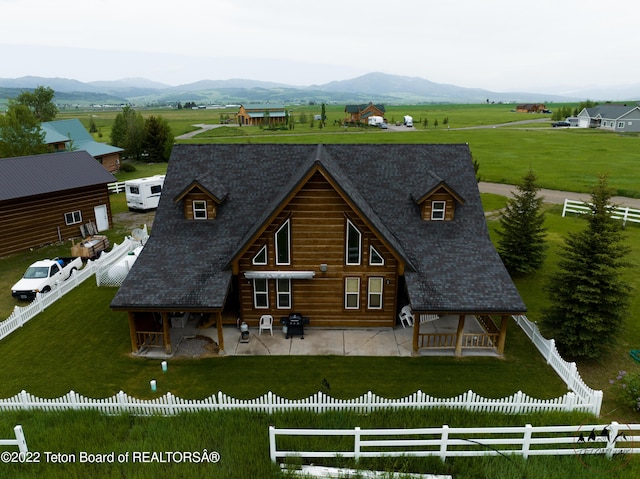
[0,100,47,158]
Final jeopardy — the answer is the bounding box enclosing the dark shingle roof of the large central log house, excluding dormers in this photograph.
[112,145,526,312]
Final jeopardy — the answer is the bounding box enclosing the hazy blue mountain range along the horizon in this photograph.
[0,72,640,106]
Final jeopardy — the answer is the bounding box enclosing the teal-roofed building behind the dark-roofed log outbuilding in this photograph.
[40,118,124,173]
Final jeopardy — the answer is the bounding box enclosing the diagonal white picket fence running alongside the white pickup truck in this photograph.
[0,238,140,340]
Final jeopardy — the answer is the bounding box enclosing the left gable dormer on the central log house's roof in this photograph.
[174,175,227,220]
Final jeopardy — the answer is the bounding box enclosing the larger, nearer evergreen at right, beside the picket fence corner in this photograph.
[544,176,631,358]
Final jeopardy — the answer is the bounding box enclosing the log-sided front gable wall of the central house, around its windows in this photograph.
[239,173,398,327]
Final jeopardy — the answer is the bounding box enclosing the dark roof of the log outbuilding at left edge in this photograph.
[0,151,116,201]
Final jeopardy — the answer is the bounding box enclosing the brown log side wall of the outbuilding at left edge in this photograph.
[0,184,112,256]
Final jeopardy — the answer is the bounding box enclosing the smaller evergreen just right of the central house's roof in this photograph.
[498,170,547,275]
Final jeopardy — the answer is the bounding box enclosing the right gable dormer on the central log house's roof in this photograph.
[411,172,464,221]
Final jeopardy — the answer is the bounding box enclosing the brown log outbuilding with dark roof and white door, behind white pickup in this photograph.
[0,151,116,256]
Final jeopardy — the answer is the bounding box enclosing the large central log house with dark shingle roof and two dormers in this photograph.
[111,144,526,353]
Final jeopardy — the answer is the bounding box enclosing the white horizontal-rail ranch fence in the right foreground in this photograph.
[269,422,640,462]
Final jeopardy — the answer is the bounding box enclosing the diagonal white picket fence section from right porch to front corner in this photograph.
[513,315,602,416]
